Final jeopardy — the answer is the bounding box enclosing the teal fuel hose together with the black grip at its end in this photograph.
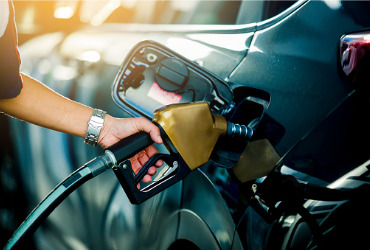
[4,132,153,250]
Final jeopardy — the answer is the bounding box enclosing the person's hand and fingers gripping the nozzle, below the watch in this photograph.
[98,115,163,182]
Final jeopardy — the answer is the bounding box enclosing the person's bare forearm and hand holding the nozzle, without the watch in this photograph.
[0,74,162,182]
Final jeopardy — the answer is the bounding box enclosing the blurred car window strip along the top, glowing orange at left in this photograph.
[14,0,294,44]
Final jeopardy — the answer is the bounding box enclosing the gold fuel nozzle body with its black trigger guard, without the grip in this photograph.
[113,102,236,204]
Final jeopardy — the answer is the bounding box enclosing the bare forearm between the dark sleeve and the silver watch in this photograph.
[0,74,93,137]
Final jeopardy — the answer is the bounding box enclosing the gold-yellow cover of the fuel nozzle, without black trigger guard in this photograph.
[153,102,227,170]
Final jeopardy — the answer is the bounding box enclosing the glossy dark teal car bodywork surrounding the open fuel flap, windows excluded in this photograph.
[11,1,364,249]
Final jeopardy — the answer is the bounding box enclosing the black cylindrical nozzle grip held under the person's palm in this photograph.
[107,131,153,164]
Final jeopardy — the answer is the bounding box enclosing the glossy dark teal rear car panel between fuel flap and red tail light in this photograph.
[229,1,363,155]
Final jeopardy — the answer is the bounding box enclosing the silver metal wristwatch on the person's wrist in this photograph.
[85,109,107,146]
